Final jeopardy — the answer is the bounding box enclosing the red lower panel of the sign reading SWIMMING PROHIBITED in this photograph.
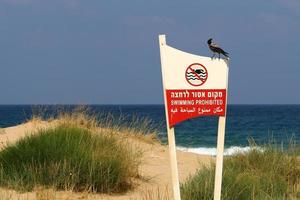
[166,89,226,127]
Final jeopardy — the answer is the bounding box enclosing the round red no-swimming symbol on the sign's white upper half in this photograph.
[185,63,208,86]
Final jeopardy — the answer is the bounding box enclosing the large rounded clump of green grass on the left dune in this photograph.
[0,124,140,193]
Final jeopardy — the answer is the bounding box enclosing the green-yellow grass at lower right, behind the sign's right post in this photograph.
[181,146,300,200]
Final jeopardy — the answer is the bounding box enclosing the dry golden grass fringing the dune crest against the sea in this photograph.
[28,105,160,144]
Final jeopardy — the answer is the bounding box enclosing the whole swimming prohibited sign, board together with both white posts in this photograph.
[159,35,228,200]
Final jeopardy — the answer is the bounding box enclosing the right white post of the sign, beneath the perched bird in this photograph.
[214,60,229,200]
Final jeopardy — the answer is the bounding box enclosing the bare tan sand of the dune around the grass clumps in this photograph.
[0,121,213,200]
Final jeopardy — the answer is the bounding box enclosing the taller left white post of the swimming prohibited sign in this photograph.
[159,35,181,200]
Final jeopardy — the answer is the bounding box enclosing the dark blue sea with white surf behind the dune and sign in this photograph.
[0,105,300,155]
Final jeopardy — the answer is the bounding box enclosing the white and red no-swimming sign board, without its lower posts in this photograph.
[160,38,229,127]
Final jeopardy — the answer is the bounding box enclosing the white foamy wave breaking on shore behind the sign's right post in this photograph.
[177,146,263,156]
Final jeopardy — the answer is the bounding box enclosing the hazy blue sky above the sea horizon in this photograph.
[0,0,300,104]
